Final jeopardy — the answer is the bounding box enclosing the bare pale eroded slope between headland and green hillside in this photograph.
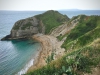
[50,16,80,38]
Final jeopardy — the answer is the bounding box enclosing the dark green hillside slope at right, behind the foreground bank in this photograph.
[62,16,100,50]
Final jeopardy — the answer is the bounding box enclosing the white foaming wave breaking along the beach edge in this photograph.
[15,59,34,75]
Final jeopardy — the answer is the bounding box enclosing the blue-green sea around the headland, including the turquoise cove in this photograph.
[0,10,100,75]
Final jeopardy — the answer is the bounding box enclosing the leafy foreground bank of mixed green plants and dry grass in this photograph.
[26,46,100,75]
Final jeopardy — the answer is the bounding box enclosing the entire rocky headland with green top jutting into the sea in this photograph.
[1,10,69,40]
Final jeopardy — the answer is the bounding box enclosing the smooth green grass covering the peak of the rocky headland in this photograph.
[35,10,69,34]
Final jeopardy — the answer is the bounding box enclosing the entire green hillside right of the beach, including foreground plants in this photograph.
[26,15,100,75]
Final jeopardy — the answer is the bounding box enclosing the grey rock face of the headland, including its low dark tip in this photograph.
[1,17,45,40]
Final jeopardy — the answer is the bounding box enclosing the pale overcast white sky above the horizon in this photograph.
[0,0,100,10]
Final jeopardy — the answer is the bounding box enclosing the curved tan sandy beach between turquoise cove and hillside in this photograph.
[27,34,65,73]
